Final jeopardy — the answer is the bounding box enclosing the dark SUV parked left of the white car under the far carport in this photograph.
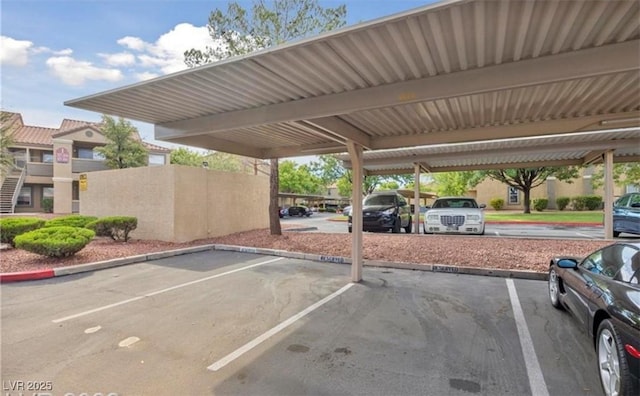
[348,191,411,234]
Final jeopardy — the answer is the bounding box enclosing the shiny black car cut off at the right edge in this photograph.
[549,243,640,395]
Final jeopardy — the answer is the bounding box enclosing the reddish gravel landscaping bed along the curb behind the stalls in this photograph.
[0,229,611,273]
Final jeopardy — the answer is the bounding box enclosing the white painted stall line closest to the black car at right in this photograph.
[506,279,549,396]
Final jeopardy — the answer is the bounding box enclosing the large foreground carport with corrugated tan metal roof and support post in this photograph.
[66,0,640,282]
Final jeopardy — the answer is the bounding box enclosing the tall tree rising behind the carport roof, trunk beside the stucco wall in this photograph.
[184,0,347,235]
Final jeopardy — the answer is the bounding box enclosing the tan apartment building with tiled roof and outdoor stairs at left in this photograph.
[0,113,171,214]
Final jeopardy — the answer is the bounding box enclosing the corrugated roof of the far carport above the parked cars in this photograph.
[337,128,640,175]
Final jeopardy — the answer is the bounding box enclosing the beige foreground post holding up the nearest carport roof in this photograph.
[347,140,362,282]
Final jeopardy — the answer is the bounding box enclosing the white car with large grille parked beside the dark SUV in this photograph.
[424,197,486,235]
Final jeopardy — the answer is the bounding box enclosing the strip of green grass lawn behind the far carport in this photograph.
[329,210,604,224]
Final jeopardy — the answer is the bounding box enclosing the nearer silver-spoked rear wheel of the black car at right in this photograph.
[596,319,631,396]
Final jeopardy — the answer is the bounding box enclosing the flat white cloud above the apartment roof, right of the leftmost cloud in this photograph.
[47,56,123,85]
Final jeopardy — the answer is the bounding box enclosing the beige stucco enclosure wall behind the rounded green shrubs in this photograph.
[80,165,269,242]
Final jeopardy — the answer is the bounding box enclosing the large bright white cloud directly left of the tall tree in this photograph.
[118,23,212,74]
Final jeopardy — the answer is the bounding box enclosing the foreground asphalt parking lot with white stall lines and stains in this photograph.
[1,251,601,395]
